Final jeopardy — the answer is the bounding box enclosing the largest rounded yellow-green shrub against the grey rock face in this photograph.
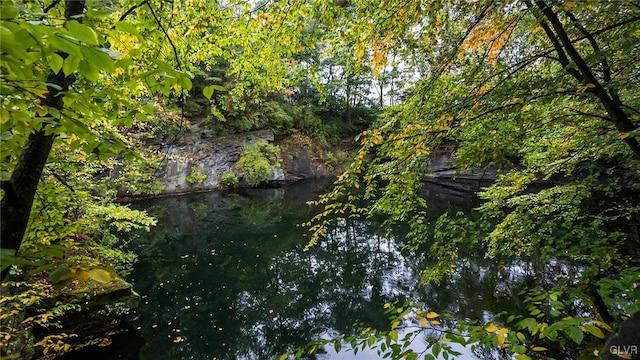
[238,141,282,186]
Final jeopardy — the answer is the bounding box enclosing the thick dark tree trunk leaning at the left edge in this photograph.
[0,0,85,280]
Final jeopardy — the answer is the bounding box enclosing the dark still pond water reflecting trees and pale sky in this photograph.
[129,181,567,360]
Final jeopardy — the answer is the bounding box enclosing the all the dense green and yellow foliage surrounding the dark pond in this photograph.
[0,0,640,359]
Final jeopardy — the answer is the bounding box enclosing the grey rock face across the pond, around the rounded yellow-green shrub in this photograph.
[138,127,341,199]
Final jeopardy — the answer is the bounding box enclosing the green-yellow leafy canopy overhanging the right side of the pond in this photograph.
[307,0,640,359]
